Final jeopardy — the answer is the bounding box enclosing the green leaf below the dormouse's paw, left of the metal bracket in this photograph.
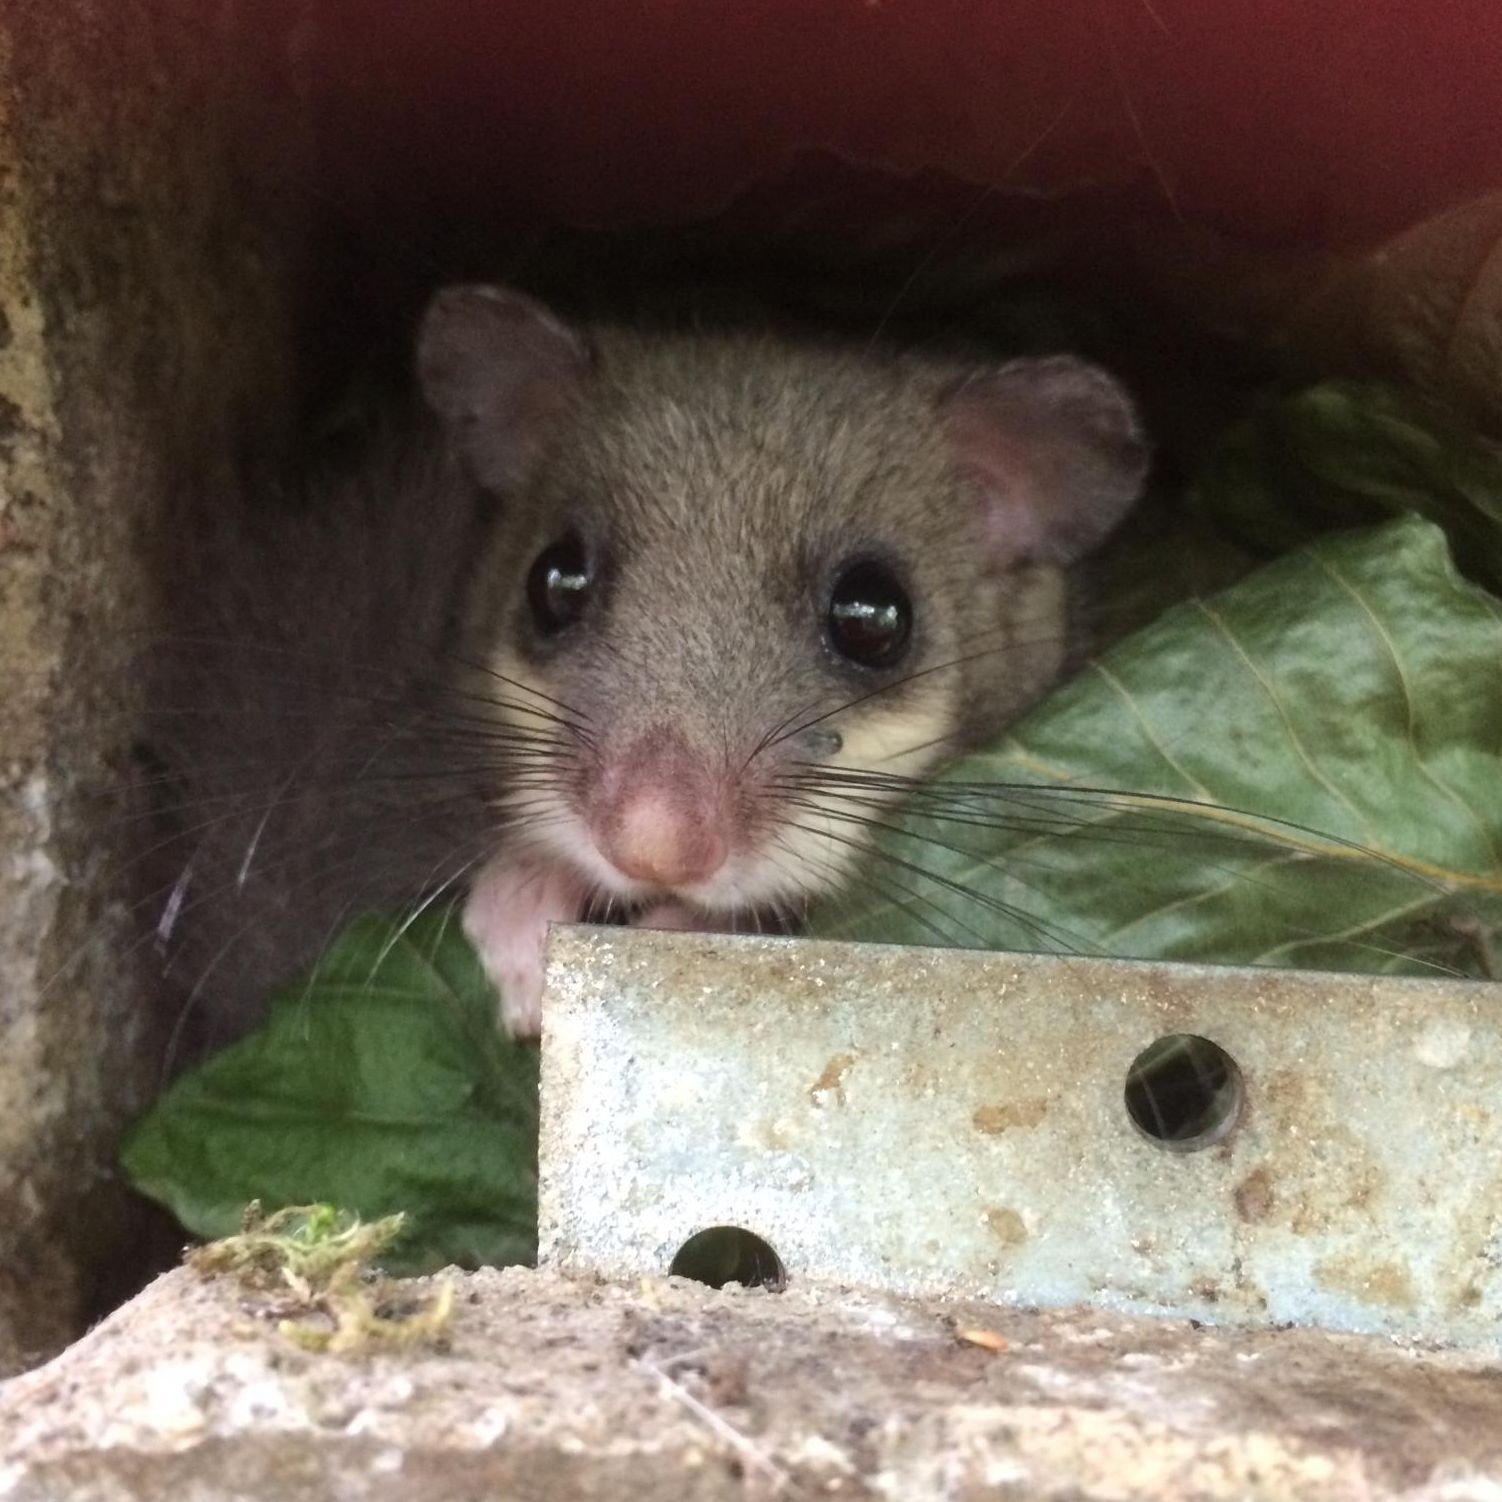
[125,912,538,1272]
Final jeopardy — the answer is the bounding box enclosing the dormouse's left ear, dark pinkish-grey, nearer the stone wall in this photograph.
[418,285,590,490]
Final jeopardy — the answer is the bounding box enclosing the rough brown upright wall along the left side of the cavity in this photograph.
[0,0,309,1371]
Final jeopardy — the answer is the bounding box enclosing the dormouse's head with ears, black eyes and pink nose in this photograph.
[418,287,1148,915]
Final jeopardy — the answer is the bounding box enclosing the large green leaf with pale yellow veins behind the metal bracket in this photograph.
[817,517,1502,973]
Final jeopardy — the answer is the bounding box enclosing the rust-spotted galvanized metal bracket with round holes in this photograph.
[541,927,1502,1350]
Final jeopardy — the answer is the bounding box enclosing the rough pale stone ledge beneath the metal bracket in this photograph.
[0,1269,1502,1502]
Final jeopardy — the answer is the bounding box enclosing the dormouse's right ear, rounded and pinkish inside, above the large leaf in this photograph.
[942,356,1148,569]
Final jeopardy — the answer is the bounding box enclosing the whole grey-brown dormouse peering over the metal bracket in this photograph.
[143,287,1148,1051]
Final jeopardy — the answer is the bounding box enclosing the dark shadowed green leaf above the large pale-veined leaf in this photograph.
[1191,380,1502,590]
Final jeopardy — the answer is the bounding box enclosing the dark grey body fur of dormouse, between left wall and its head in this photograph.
[137,436,490,1056]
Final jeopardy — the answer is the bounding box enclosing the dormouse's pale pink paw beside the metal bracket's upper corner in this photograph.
[464,856,587,1038]
